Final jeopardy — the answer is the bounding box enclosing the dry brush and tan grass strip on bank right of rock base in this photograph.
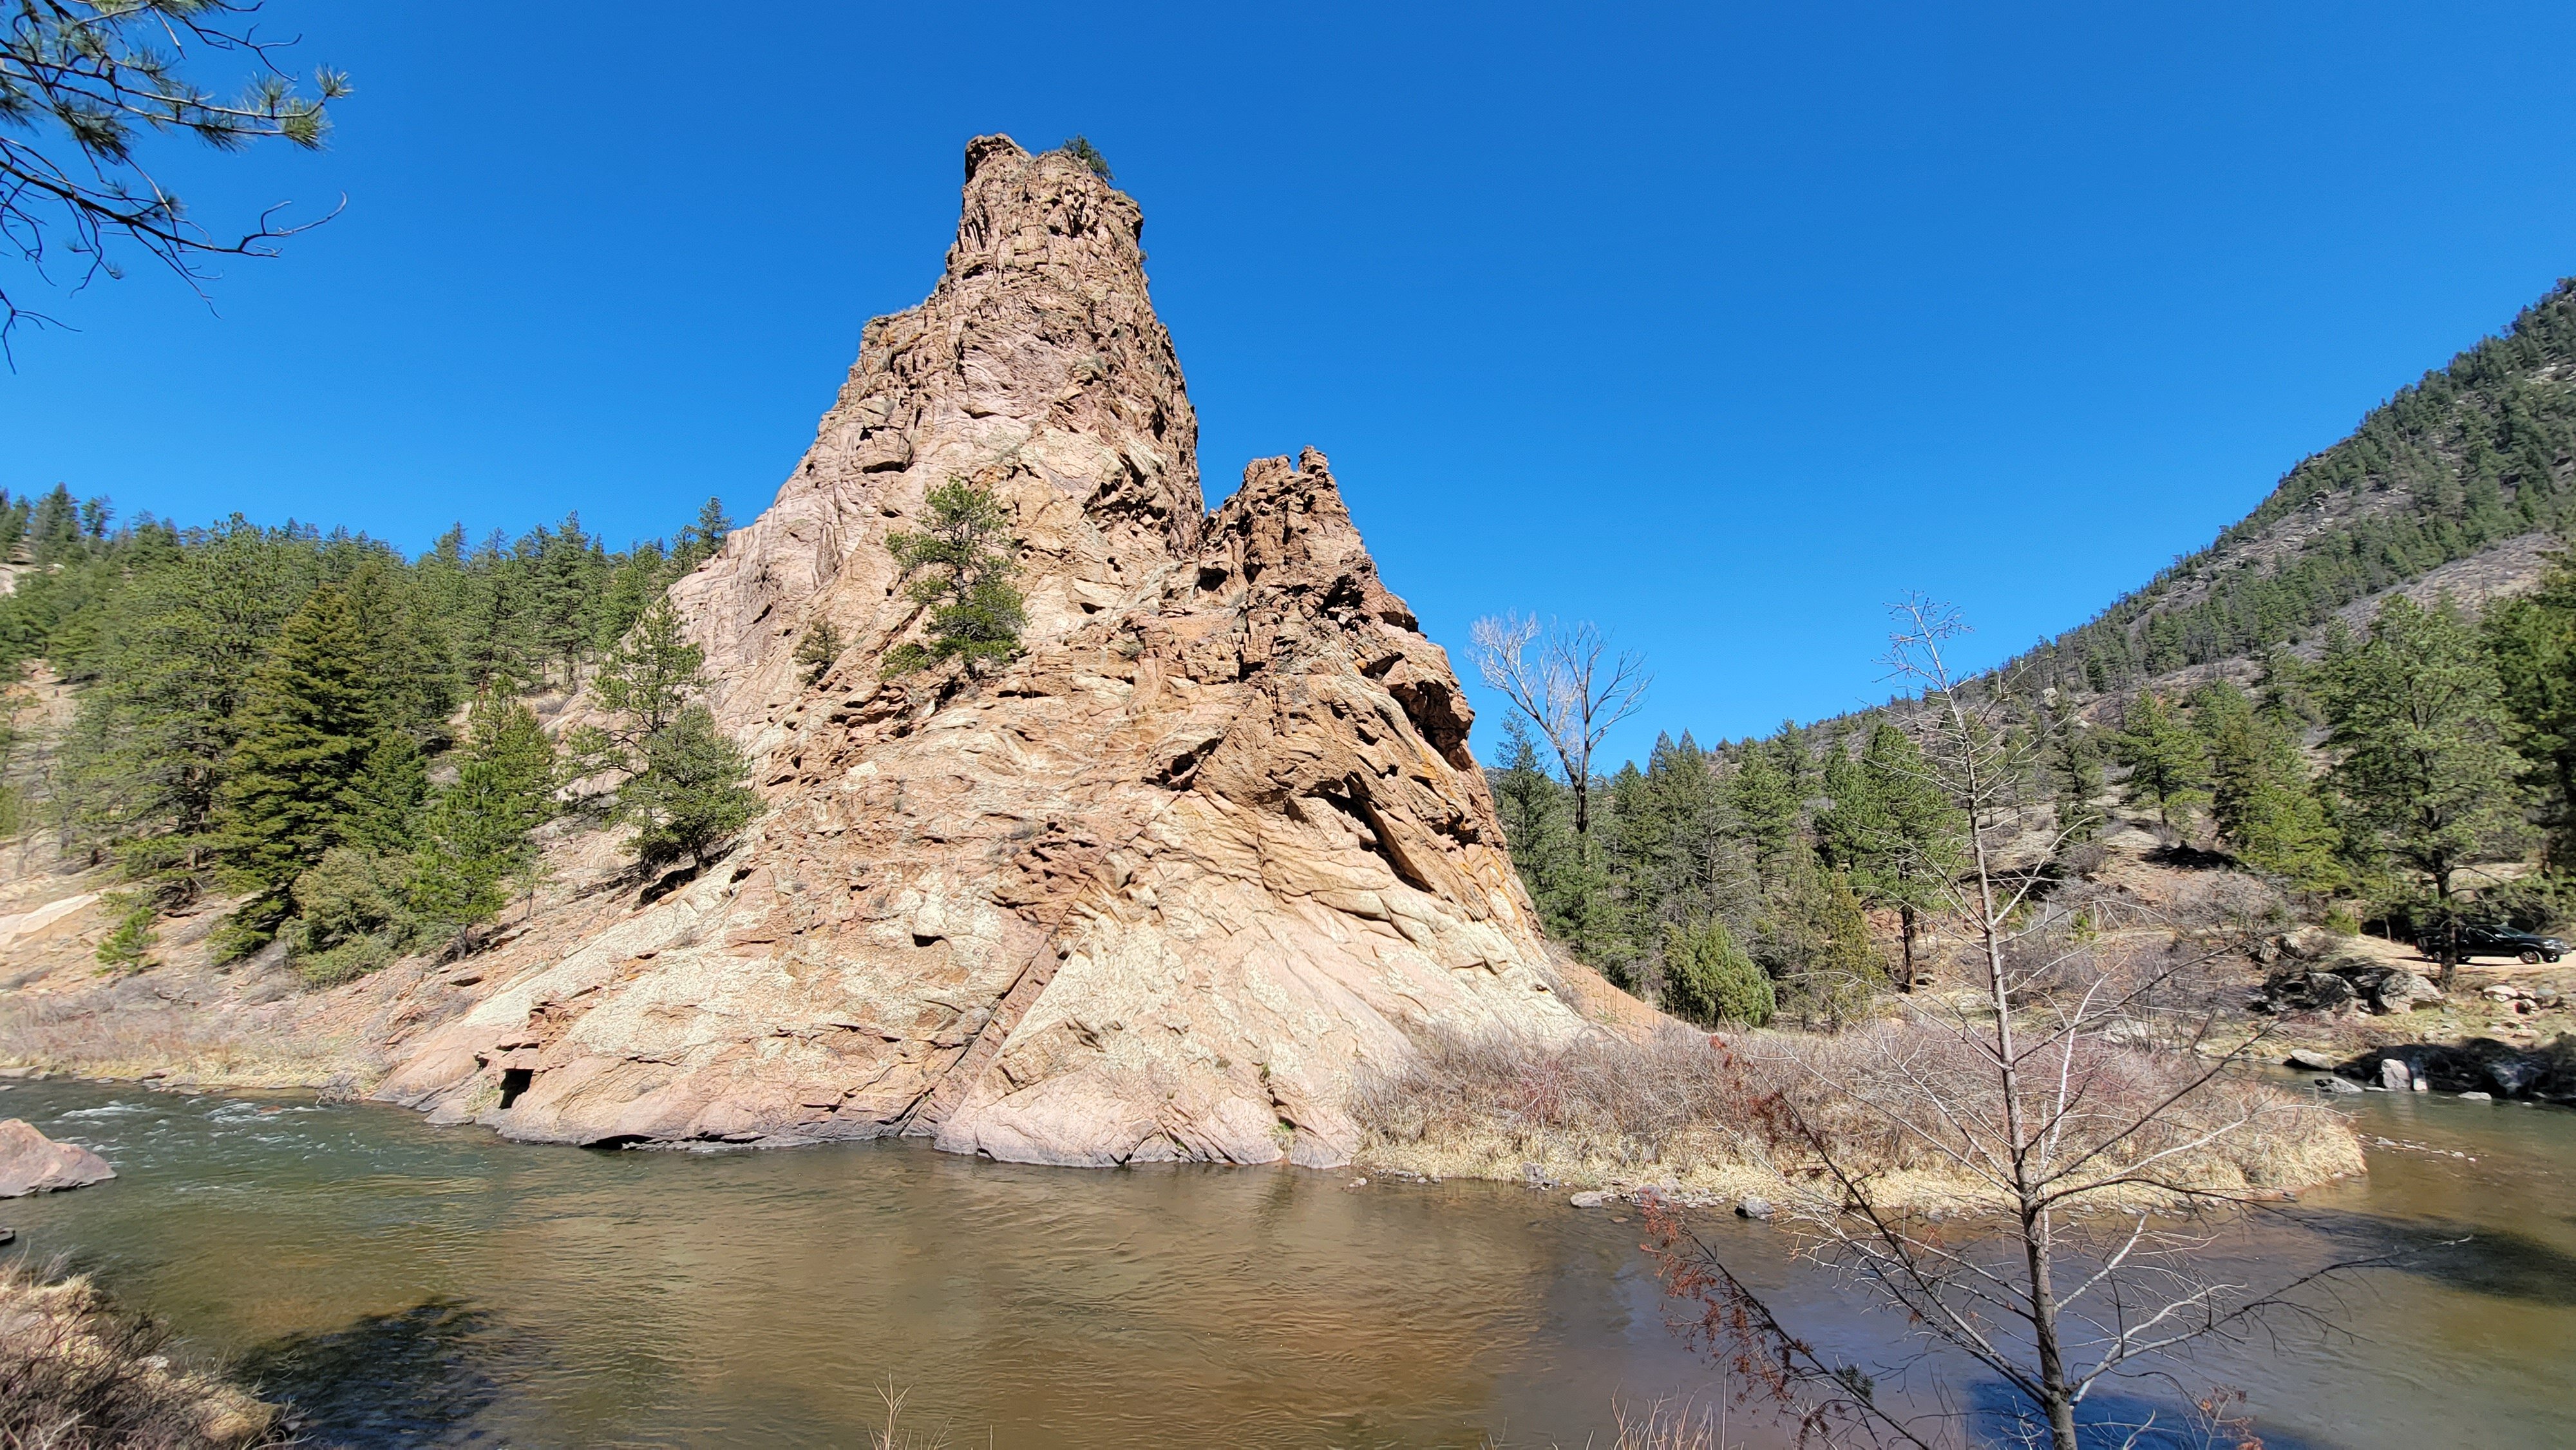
[1355,1022,2362,1210]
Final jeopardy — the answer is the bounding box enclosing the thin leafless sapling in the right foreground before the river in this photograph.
[1649,598,2357,1450]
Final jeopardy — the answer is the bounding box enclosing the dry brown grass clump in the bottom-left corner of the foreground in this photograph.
[0,1265,291,1450]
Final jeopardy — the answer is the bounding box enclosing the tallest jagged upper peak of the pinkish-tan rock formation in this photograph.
[672,137,1203,729]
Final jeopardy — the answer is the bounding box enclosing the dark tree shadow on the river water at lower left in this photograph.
[237,1298,526,1450]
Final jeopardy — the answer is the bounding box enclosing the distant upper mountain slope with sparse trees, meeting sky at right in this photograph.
[2014,281,2576,693]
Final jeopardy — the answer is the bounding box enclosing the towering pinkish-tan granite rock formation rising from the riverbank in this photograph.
[381,137,1587,1164]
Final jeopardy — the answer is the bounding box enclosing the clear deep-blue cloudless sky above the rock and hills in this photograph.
[0,0,2576,773]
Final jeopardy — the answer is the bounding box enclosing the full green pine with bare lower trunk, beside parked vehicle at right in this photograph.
[2321,595,2522,986]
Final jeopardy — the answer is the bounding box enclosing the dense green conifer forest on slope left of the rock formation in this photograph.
[0,487,742,981]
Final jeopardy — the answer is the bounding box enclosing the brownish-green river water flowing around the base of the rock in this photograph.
[0,1082,2576,1450]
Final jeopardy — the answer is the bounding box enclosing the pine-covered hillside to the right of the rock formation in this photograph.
[1489,283,2576,1022]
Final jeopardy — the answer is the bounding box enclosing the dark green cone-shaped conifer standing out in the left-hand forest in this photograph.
[216,585,381,953]
